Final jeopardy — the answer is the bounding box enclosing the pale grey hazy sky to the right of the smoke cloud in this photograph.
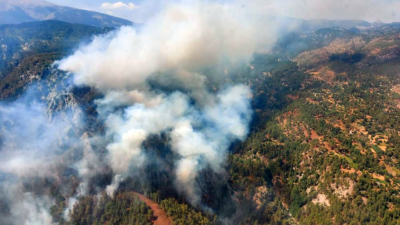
[241,0,400,22]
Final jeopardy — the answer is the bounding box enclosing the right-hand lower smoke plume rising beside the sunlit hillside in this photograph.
[171,85,251,203]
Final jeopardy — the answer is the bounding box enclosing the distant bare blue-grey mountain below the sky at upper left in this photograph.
[0,0,132,27]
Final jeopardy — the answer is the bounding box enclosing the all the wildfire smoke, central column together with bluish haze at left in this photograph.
[0,1,284,225]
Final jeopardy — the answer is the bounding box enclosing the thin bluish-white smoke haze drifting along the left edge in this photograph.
[0,88,82,225]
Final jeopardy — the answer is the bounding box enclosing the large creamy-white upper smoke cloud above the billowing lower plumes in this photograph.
[60,2,274,90]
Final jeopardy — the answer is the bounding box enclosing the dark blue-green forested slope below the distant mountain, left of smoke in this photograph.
[0,20,112,99]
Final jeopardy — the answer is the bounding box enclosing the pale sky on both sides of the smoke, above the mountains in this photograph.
[47,0,400,23]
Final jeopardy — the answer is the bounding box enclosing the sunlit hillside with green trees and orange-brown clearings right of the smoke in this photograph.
[230,23,400,224]
